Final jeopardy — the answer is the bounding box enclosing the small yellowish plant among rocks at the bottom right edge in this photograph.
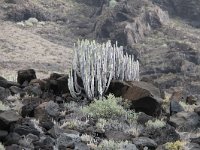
[165,141,185,150]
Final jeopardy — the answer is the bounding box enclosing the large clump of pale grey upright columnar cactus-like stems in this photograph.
[68,40,139,99]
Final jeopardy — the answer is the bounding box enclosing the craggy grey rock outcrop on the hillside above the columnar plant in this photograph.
[94,0,169,48]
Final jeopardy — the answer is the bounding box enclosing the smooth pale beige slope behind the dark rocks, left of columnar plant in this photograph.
[0,22,72,77]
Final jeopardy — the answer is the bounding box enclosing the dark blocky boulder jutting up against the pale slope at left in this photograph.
[17,69,36,85]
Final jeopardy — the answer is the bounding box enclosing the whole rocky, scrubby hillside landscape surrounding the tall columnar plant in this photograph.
[0,0,200,150]
